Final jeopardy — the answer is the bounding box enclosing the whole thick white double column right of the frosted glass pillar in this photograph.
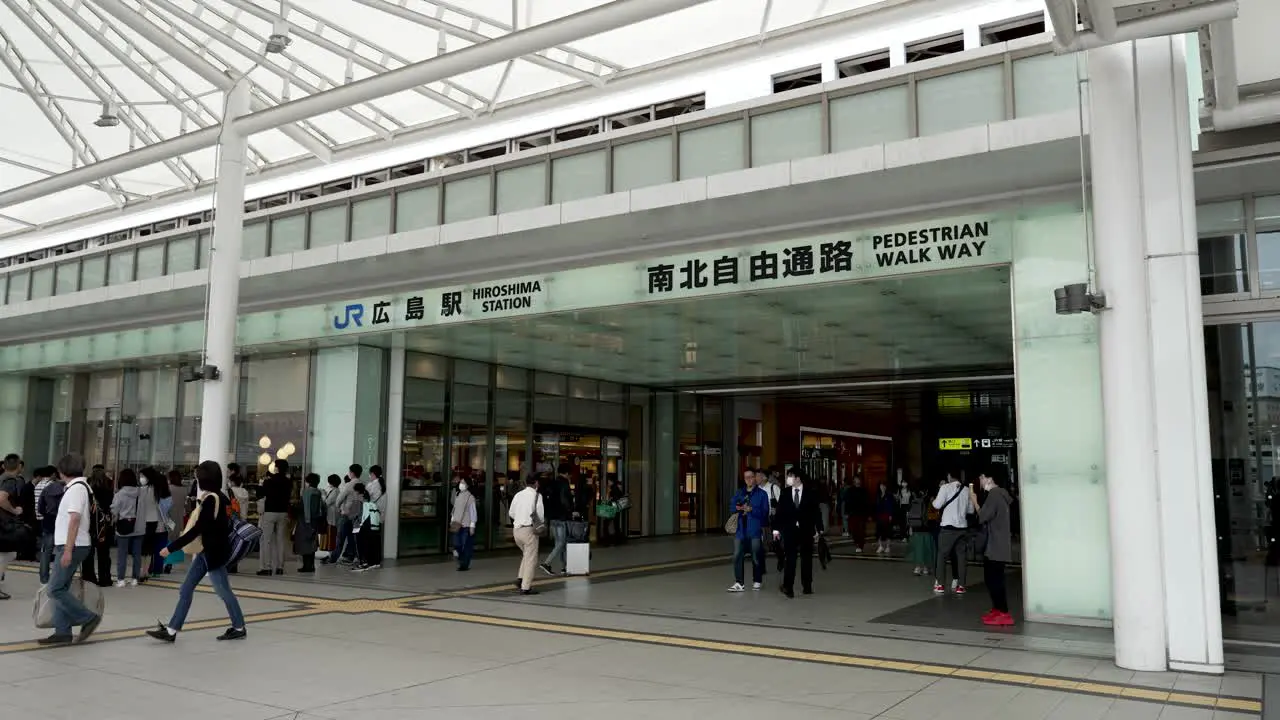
[1088,37,1222,673]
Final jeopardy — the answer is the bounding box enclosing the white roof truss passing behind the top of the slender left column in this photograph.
[60,0,268,165]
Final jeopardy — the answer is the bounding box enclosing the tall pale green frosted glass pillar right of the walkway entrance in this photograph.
[1012,206,1111,620]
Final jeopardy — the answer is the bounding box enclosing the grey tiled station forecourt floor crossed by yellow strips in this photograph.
[0,538,1262,720]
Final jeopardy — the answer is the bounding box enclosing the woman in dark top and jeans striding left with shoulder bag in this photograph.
[147,460,248,643]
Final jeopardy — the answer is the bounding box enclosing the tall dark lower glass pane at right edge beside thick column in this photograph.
[1204,322,1280,642]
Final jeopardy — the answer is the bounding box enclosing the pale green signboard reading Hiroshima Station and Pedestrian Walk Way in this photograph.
[324,218,1012,334]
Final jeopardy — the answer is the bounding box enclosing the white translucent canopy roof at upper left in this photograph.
[0,0,880,237]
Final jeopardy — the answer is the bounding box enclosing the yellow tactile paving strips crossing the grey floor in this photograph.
[0,559,1262,714]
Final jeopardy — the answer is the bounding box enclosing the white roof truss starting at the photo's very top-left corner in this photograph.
[0,0,204,190]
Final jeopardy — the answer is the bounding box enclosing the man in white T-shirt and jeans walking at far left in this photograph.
[40,454,102,646]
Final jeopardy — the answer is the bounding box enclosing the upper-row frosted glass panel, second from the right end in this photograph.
[915,65,1005,136]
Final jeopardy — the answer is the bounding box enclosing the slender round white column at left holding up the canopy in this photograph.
[200,78,250,464]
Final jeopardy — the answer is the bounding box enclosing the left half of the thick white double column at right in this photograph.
[1088,39,1167,671]
